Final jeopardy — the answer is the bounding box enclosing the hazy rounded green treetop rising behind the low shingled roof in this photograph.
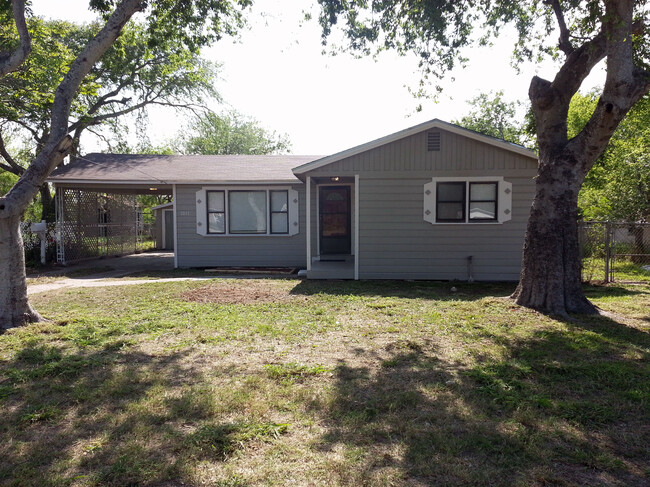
[176,111,291,154]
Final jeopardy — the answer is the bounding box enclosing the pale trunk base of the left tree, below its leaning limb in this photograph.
[0,216,43,330]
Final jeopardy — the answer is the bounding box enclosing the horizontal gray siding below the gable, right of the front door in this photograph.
[359,177,534,281]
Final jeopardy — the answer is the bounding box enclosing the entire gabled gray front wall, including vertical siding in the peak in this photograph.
[306,131,537,280]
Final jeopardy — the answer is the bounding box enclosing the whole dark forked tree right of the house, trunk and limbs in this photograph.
[512,0,650,316]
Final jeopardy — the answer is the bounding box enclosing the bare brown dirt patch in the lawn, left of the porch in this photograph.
[181,279,297,304]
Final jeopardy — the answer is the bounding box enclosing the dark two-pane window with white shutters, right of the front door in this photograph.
[424,177,512,224]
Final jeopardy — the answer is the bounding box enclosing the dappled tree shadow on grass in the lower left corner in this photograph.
[0,346,276,486]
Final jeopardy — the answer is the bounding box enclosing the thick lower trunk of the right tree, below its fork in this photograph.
[512,155,596,316]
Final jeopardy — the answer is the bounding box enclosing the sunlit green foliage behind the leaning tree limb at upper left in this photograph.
[0,18,216,163]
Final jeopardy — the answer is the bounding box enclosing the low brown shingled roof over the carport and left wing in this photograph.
[47,153,322,185]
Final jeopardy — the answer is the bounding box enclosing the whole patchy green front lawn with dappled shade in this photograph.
[0,279,650,487]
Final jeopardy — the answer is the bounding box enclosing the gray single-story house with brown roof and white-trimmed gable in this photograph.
[49,119,537,280]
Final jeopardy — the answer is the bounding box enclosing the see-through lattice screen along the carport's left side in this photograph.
[56,188,142,263]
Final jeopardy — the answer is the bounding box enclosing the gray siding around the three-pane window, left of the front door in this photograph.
[175,185,306,268]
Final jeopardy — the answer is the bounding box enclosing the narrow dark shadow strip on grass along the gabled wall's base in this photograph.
[291,280,516,301]
